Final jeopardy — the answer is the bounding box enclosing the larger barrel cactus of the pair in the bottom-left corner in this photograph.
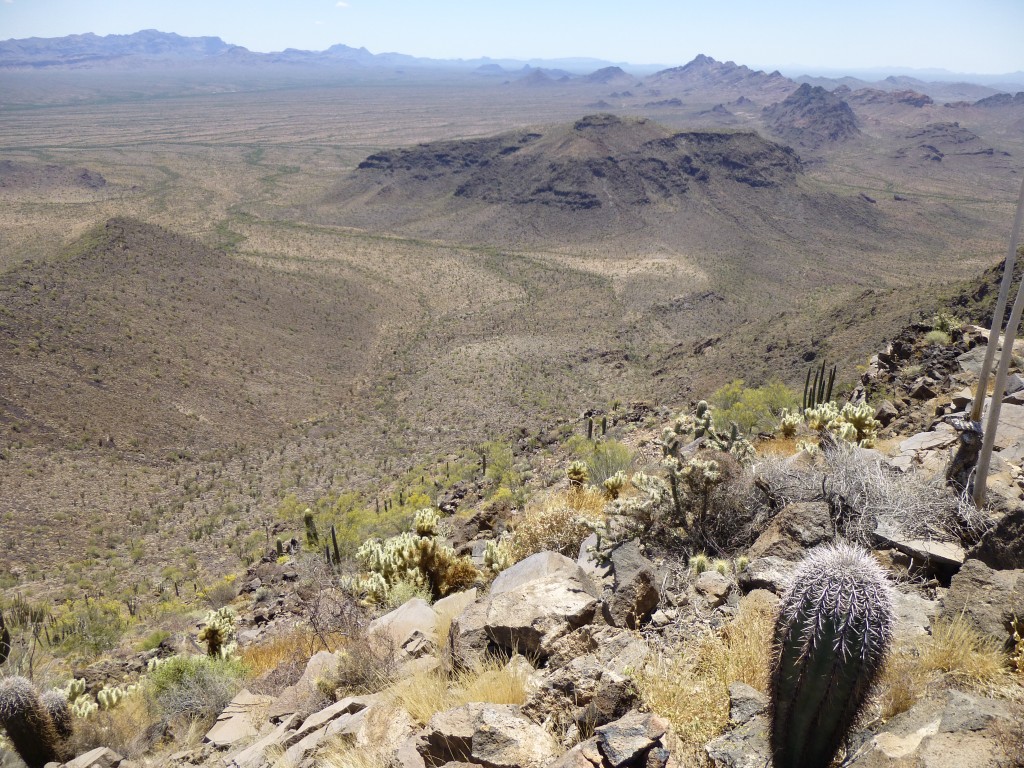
[0,677,67,768]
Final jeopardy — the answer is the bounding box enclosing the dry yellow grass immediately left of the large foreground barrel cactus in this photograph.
[636,604,774,766]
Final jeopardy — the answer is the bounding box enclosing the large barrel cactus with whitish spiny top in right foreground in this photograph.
[769,544,895,768]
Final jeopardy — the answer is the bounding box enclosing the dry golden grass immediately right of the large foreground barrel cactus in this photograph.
[876,616,1024,719]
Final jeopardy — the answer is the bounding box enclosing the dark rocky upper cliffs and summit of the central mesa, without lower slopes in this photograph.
[358,115,800,210]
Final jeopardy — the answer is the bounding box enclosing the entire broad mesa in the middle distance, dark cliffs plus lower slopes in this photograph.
[319,115,897,258]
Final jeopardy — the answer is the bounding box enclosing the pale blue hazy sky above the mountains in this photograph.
[0,0,1024,74]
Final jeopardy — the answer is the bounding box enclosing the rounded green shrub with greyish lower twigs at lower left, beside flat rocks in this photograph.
[148,656,245,722]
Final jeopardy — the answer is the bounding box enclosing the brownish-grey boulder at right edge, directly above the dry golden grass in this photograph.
[941,560,1024,647]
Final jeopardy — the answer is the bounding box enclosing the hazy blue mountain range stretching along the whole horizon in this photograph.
[0,30,1024,100]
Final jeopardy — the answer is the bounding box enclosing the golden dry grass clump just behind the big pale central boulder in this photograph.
[510,487,607,562]
